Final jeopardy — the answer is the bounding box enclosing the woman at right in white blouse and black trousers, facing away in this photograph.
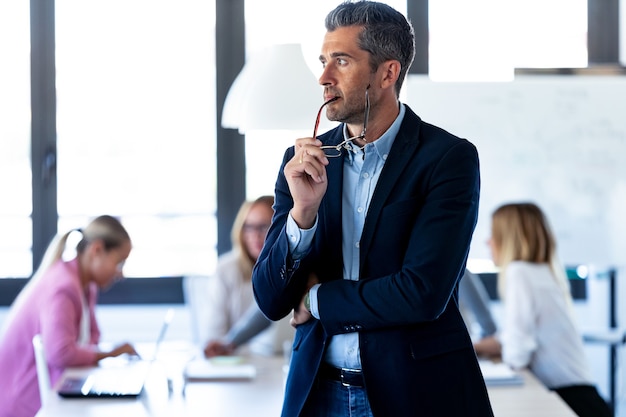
[489,203,613,417]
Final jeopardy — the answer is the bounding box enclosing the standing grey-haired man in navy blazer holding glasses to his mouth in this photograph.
[252,1,493,417]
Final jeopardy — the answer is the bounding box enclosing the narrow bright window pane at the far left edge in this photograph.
[0,0,32,277]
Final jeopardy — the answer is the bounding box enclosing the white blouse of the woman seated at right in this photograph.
[500,261,591,388]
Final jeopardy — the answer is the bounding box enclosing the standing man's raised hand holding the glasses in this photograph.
[284,138,328,229]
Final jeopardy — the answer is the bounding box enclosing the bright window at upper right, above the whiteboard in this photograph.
[429,0,587,81]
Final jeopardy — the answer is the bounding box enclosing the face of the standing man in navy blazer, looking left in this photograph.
[319,26,373,124]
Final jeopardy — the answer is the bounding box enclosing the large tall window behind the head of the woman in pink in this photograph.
[56,0,217,277]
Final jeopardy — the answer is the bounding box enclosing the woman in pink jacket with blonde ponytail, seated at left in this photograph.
[0,215,137,417]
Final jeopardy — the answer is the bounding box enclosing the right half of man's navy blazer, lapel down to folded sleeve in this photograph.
[317,124,480,334]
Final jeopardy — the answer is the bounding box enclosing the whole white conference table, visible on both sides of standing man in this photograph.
[36,342,575,417]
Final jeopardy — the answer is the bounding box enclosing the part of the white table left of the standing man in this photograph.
[36,344,284,417]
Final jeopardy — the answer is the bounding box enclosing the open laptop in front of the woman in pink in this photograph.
[57,309,174,398]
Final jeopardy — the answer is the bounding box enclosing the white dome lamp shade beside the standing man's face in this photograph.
[222,44,323,133]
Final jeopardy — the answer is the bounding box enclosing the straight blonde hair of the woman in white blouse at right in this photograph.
[491,203,572,303]
